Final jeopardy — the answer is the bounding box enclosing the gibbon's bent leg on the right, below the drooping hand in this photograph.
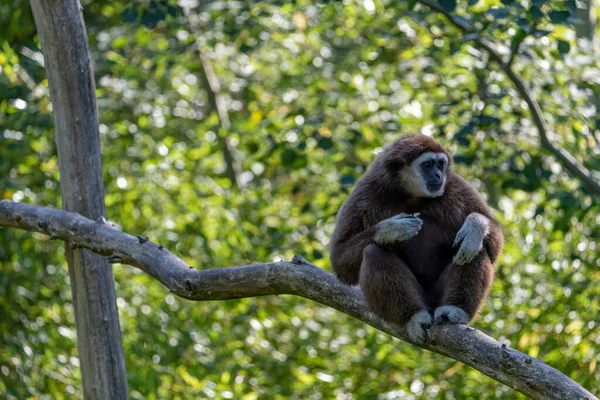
[433,250,494,324]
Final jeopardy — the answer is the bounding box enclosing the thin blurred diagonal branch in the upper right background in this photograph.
[418,0,600,195]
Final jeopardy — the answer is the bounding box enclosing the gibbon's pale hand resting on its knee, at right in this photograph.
[452,213,489,265]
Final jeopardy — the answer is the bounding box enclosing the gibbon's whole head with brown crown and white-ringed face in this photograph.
[381,134,452,197]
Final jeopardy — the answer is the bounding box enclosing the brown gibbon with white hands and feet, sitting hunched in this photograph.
[331,135,503,342]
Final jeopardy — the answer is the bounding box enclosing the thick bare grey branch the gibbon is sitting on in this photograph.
[0,200,598,400]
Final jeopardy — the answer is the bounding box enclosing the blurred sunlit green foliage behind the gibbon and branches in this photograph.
[0,0,600,400]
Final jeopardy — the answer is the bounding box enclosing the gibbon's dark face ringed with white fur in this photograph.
[400,152,448,197]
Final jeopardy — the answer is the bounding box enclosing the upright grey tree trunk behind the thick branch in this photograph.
[31,0,127,400]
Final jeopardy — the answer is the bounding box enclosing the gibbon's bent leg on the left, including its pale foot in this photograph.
[359,243,433,343]
